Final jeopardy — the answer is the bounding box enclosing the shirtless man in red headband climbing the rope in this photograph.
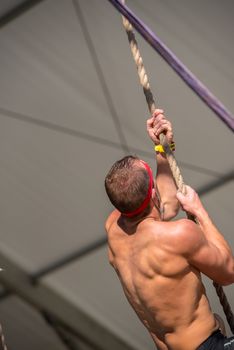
[105,110,234,350]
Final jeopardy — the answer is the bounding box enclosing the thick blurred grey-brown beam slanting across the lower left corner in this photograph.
[0,253,134,350]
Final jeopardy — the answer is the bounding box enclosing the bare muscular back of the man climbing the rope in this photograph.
[107,212,217,350]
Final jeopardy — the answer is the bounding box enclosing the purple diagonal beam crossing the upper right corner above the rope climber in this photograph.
[108,0,234,131]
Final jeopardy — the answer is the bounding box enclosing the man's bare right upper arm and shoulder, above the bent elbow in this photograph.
[177,220,234,285]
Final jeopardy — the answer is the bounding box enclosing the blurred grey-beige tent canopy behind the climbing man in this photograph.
[0,0,234,350]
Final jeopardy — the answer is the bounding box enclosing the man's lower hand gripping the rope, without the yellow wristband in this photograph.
[176,186,204,217]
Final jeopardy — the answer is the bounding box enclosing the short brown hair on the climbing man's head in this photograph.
[105,156,149,213]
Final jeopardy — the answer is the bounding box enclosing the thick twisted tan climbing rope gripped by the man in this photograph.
[119,0,234,334]
